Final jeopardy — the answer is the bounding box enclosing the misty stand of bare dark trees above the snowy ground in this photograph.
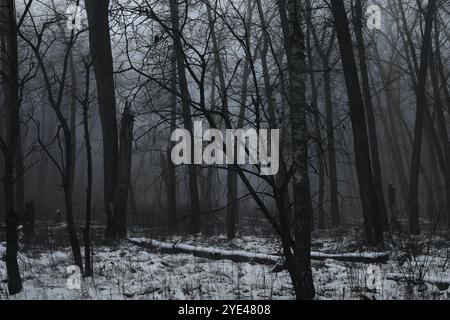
[0,0,450,299]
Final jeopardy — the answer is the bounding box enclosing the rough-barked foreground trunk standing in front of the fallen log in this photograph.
[277,0,315,300]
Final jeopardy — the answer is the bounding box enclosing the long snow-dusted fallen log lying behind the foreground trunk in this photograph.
[129,238,389,270]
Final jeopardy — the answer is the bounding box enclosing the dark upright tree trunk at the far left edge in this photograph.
[0,0,22,295]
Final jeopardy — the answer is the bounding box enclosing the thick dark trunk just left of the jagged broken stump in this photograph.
[85,0,119,240]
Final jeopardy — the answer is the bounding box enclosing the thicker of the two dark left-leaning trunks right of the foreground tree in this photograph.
[331,1,383,245]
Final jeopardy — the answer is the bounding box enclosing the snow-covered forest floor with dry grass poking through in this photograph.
[0,226,450,300]
